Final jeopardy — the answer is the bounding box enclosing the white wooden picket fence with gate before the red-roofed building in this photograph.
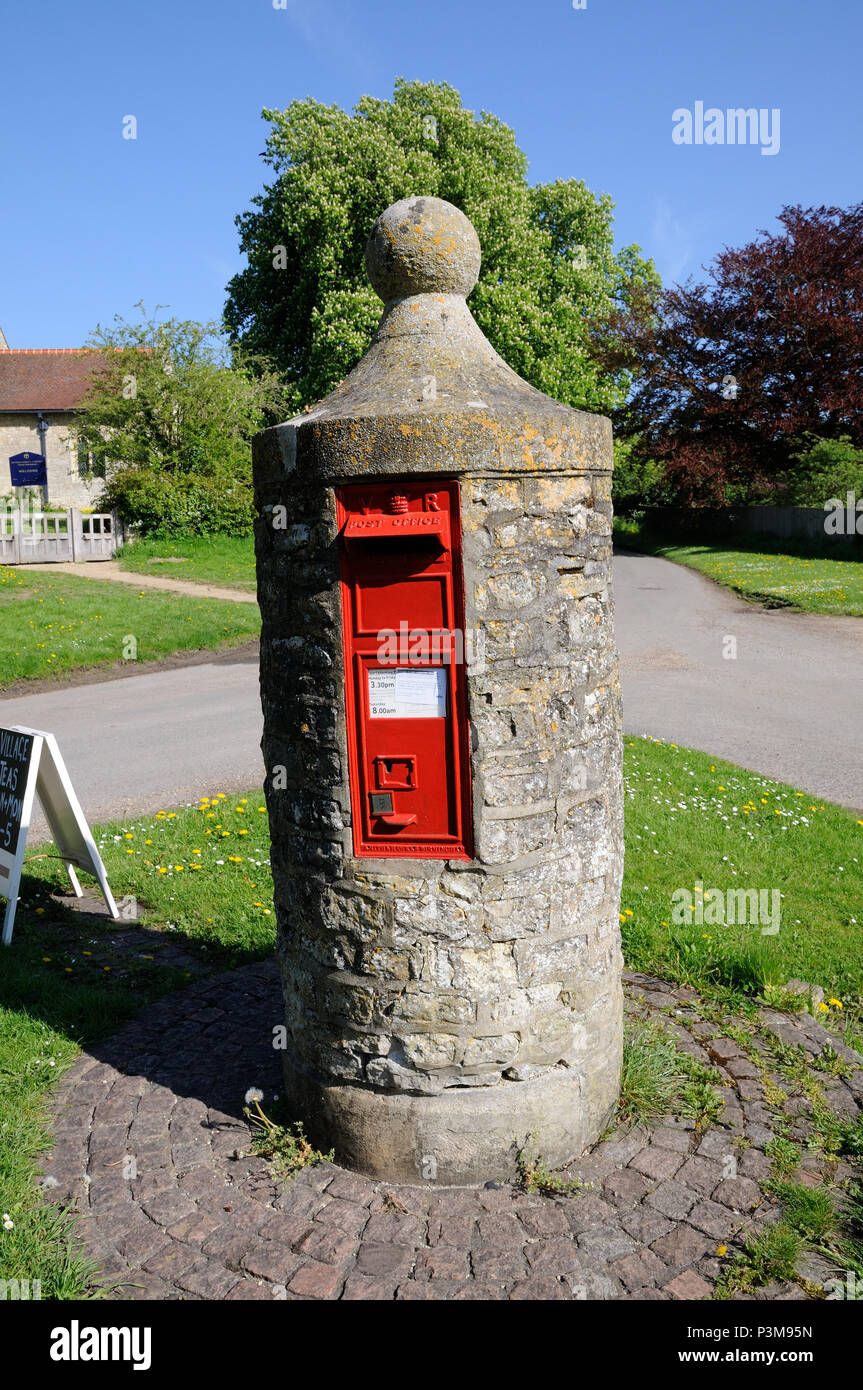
[0,507,122,564]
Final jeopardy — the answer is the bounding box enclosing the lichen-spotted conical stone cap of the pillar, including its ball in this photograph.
[252,197,611,481]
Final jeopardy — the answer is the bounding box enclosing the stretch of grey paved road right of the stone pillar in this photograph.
[614,555,863,810]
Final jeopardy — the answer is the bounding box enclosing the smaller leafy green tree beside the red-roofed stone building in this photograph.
[75,304,286,531]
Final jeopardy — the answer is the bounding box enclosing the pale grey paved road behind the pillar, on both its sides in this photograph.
[0,555,863,833]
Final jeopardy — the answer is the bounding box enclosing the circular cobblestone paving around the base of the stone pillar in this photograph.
[40,962,863,1301]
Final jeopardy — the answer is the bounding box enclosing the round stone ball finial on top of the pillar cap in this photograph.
[365,197,482,303]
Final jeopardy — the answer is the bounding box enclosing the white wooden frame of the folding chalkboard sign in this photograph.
[0,724,120,947]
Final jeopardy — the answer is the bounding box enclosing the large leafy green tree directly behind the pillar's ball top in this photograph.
[225,79,659,411]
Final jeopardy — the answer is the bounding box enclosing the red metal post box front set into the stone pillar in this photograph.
[336,481,471,859]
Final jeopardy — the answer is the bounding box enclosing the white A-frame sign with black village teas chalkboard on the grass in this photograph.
[0,726,120,947]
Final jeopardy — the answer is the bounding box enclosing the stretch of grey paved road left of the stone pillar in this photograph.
[0,655,264,840]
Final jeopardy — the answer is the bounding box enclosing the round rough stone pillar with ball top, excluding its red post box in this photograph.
[254,197,623,1184]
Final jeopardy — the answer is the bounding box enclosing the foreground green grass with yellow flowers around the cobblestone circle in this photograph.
[0,738,863,1297]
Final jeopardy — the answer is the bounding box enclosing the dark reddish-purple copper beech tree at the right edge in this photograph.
[595,195,863,505]
